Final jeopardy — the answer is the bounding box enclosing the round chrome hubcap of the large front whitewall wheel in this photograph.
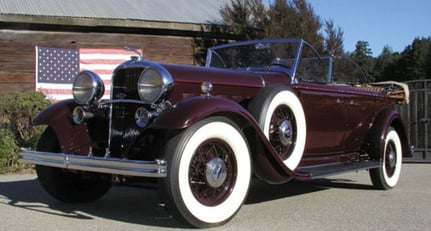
[205,157,227,188]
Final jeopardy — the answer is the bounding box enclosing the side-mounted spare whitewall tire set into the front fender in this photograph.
[248,85,307,170]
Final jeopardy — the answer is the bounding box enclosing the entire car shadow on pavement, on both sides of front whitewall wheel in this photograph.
[0,175,368,228]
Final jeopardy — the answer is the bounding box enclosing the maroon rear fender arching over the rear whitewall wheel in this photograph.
[364,109,411,160]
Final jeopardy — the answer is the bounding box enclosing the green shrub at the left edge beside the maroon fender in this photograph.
[0,92,51,172]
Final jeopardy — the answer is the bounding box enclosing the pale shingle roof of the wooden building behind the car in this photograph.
[0,0,230,24]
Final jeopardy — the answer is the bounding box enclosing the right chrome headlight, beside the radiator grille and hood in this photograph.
[138,66,174,103]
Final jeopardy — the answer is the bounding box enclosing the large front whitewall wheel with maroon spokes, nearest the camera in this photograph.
[160,117,251,228]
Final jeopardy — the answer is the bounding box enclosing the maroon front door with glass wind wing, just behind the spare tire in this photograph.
[292,50,348,156]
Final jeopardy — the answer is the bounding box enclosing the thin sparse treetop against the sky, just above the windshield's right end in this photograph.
[324,20,344,56]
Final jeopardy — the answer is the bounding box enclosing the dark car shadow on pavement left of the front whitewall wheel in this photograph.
[0,179,187,228]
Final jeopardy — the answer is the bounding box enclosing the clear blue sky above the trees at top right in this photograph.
[307,0,431,56]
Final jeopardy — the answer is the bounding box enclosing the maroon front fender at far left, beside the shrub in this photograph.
[34,100,91,154]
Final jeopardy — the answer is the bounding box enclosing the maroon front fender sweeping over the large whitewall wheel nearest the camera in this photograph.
[151,96,296,184]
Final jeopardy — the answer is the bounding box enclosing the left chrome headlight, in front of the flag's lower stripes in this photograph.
[72,71,105,104]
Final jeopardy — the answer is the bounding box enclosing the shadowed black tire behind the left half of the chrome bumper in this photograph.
[36,127,111,203]
